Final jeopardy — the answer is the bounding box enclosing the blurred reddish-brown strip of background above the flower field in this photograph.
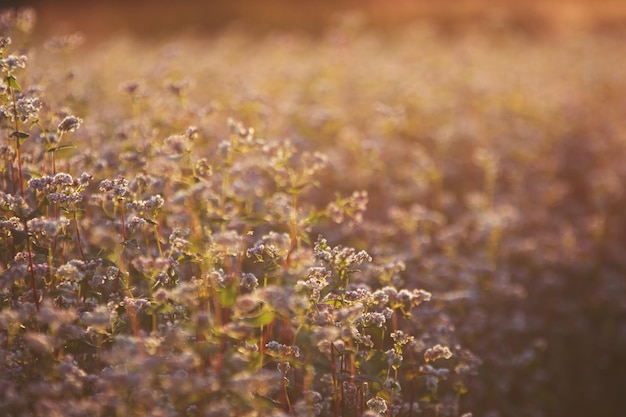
[7,0,626,39]
